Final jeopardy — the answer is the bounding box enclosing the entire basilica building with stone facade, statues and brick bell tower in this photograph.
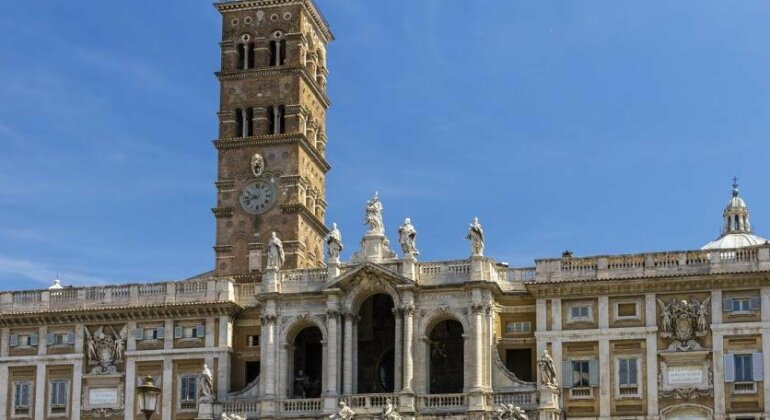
[0,0,770,420]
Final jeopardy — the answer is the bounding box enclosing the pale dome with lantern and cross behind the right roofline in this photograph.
[701,178,768,249]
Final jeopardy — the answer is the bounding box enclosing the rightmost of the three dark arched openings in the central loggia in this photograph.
[428,319,464,394]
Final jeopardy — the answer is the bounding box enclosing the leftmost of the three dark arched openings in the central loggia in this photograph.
[291,327,323,398]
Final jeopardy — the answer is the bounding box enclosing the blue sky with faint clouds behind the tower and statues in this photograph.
[0,0,770,289]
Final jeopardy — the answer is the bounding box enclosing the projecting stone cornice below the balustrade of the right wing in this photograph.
[525,271,770,298]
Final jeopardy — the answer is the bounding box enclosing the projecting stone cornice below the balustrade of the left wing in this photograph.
[0,301,244,327]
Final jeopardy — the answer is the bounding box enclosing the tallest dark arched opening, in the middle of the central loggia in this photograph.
[357,293,396,394]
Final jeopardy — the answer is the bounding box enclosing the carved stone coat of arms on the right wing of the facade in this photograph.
[658,297,711,351]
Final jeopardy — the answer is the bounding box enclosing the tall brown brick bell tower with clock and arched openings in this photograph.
[213,0,333,278]
